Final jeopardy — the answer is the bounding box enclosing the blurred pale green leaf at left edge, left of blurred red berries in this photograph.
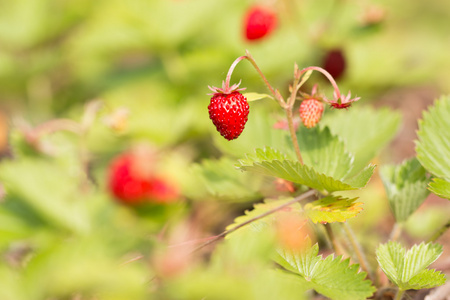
[0,159,89,233]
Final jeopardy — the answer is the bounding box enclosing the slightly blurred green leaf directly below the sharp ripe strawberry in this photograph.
[192,158,262,201]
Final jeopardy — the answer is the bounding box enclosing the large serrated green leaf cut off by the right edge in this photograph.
[416,96,450,181]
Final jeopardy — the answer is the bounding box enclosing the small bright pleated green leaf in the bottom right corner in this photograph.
[376,242,445,290]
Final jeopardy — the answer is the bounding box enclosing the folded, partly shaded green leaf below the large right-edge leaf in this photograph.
[380,158,429,222]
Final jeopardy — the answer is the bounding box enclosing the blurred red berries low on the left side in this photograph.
[108,153,178,205]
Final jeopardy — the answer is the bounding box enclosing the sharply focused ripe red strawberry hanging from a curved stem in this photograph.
[208,91,249,141]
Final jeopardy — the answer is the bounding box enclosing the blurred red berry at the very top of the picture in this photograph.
[244,6,278,41]
